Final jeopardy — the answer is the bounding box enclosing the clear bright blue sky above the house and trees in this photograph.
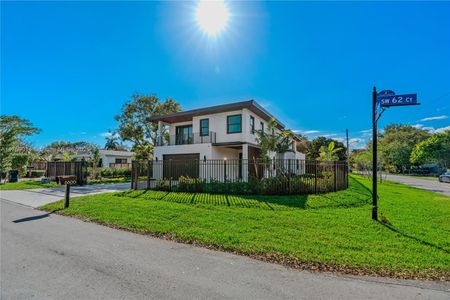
[1,2,450,147]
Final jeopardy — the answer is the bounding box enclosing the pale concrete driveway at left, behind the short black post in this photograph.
[0,182,131,207]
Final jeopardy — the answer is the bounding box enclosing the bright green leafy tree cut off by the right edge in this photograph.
[410,130,450,169]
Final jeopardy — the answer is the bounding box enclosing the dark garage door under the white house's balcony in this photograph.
[163,153,200,179]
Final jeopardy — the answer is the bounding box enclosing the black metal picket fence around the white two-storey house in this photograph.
[131,159,348,195]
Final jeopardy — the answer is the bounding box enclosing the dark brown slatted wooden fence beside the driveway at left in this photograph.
[46,161,88,185]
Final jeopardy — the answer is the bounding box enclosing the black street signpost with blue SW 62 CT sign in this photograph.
[372,87,420,220]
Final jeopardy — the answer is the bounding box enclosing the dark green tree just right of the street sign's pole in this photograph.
[379,124,430,171]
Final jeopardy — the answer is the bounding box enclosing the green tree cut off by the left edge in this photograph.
[0,115,40,180]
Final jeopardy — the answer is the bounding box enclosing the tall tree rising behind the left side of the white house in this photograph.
[115,94,181,158]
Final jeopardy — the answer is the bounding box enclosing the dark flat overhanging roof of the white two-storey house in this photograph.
[147,100,285,129]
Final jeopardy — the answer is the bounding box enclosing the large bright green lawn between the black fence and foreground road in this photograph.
[43,176,450,280]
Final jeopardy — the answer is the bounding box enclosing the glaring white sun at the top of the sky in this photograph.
[195,0,230,36]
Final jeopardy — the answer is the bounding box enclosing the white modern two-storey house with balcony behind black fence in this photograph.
[148,100,305,179]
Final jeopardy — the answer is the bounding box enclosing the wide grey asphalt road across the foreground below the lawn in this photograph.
[0,200,450,300]
